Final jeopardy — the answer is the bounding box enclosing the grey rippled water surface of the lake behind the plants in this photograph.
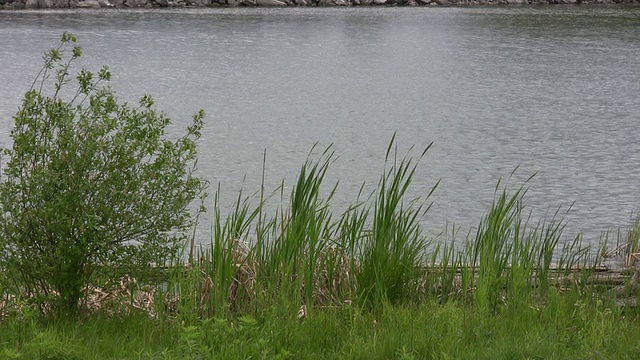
[0,7,640,246]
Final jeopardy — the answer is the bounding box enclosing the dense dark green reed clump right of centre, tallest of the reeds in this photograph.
[356,135,438,304]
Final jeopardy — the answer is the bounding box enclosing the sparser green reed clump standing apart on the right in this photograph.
[463,178,576,310]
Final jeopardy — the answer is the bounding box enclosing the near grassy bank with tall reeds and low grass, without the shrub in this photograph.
[0,143,640,359]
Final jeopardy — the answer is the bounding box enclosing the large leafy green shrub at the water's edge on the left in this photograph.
[0,33,206,313]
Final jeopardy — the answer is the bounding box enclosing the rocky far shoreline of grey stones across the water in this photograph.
[0,0,640,10]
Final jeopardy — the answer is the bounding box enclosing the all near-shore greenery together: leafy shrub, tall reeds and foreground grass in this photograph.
[0,33,640,359]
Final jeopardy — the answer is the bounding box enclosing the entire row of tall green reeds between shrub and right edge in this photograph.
[144,139,638,322]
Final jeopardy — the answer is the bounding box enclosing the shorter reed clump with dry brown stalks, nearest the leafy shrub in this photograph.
[165,186,259,321]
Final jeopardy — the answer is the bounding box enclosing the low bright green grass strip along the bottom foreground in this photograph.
[0,293,640,359]
